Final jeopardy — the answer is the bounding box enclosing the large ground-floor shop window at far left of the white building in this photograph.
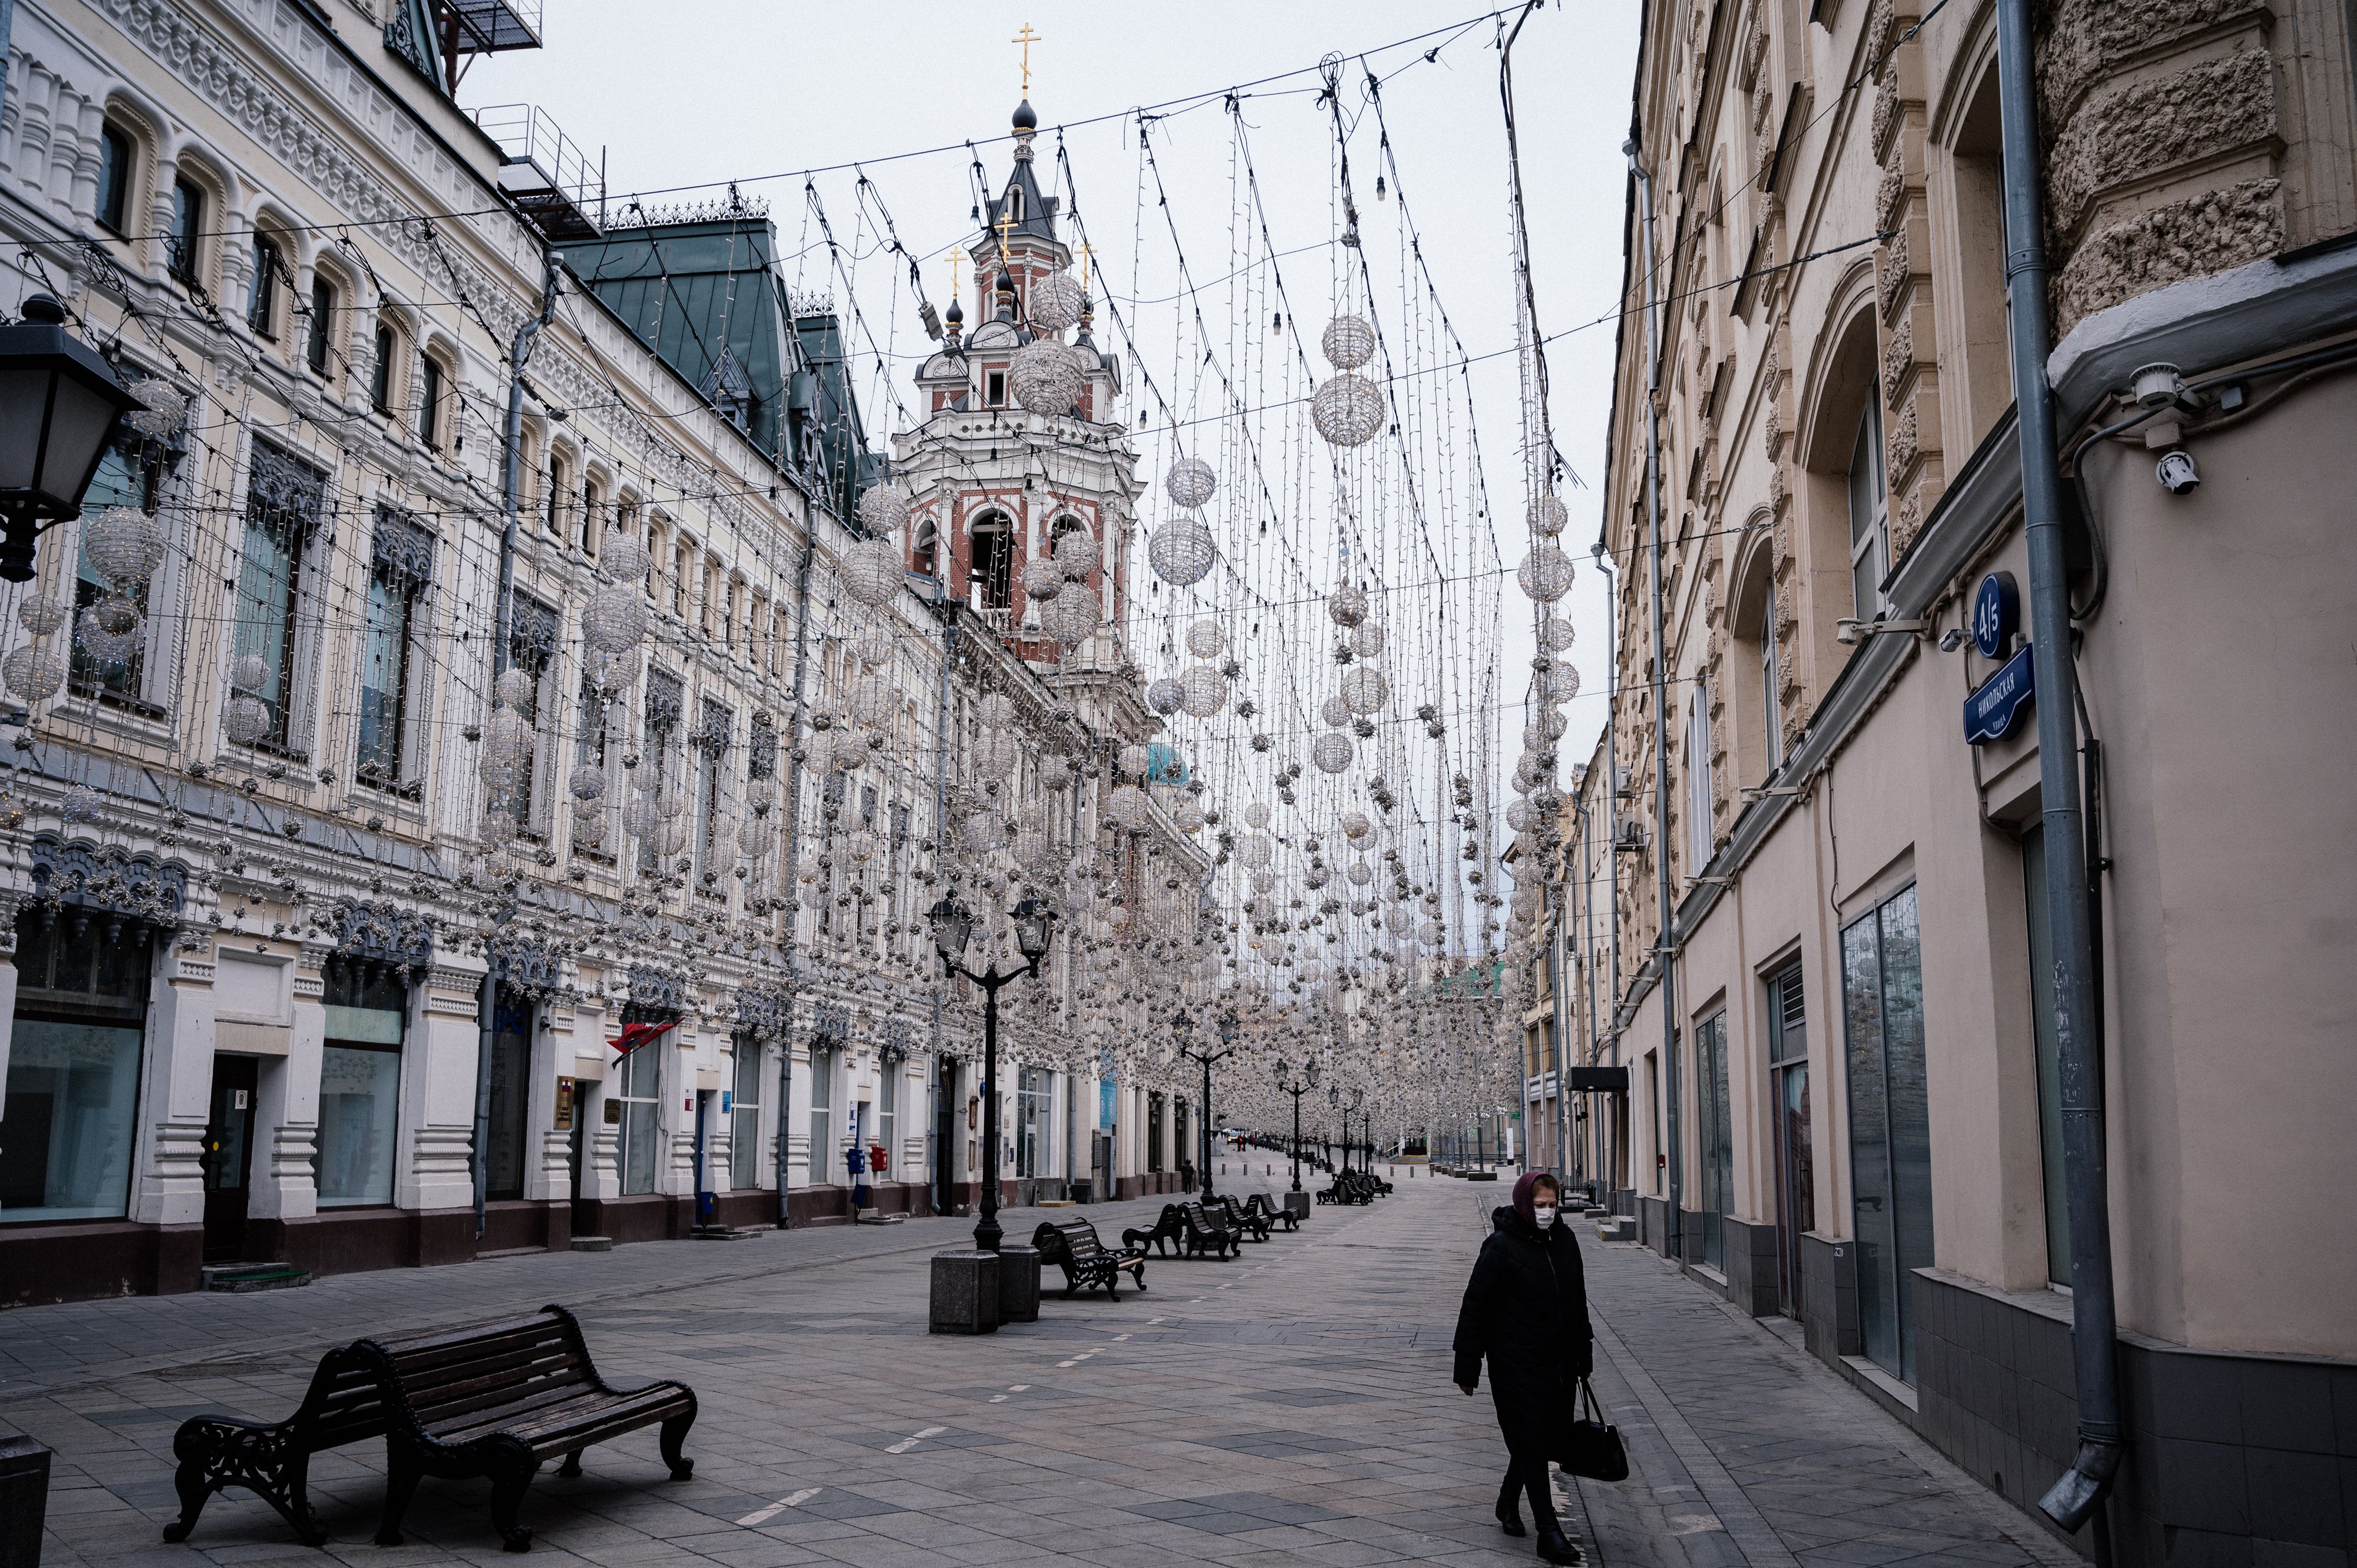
[0,908,153,1222]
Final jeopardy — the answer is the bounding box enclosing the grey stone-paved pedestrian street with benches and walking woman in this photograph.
[0,1170,2074,1568]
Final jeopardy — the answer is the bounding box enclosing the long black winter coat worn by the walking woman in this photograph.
[1454,1207,1596,1457]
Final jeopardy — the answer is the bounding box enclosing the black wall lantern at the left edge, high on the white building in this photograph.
[0,295,141,582]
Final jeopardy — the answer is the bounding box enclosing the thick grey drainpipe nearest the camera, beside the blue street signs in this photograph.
[1996,0,2126,1530]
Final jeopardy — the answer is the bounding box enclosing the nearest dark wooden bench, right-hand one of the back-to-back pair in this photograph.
[351,1306,695,1552]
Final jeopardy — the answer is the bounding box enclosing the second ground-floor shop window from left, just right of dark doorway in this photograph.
[311,960,410,1210]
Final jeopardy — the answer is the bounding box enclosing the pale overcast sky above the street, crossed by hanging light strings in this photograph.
[460,0,1638,844]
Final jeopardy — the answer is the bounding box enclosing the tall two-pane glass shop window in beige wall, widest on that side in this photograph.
[1841,887,1933,1384]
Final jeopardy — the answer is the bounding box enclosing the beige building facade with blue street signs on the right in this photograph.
[1556,0,2357,1561]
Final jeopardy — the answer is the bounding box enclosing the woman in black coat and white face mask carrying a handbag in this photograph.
[1457,1172,1596,1563]
